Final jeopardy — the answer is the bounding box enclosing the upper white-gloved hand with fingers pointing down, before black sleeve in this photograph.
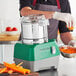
[53,12,74,28]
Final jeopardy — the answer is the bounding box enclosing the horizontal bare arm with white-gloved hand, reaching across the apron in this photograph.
[20,6,74,27]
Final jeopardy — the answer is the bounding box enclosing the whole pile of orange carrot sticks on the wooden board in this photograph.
[0,62,30,74]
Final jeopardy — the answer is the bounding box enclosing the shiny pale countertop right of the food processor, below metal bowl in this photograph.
[39,55,76,76]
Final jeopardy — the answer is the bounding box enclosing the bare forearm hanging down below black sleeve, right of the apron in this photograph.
[60,32,73,45]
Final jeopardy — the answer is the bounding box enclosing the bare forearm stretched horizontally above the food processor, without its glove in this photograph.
[20,7,55,19]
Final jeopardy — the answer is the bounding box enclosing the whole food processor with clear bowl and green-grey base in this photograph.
[14,14,60,72]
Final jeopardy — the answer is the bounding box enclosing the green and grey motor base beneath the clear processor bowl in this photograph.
[14,39,60,72]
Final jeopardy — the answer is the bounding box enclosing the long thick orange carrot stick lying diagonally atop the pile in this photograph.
[4,62,30,74]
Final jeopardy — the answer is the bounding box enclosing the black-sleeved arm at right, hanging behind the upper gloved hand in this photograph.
[59,0,73,44]
